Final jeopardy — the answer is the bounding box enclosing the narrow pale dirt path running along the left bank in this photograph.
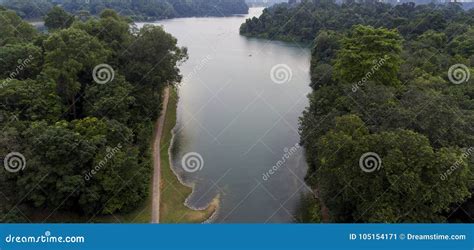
[151,88,170,223]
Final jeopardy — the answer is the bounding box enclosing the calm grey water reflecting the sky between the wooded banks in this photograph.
[139,8,310,222]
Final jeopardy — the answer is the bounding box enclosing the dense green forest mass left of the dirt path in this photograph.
[0,7,187,222]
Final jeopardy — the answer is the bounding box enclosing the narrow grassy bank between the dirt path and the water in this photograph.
[160,89,219,223]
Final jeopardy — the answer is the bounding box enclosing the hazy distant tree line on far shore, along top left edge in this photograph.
[3,0,248,21]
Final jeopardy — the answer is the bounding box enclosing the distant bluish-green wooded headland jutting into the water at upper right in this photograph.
[240,0,474,42]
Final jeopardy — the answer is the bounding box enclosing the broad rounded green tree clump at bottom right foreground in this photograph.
[317,115,470,222]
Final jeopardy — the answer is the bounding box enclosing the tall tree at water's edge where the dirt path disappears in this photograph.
[123,25,187,119]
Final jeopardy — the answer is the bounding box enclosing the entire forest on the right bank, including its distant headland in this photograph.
[241,0,474,223]
